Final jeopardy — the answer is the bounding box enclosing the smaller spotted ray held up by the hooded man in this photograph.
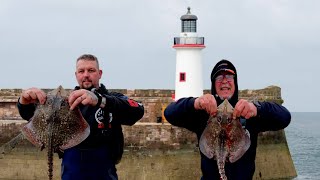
[199,99,251,180]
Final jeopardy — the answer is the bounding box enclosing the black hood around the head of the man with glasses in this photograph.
[211,59,239,107]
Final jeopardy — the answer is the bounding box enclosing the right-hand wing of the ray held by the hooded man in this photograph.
[229,119,251,163]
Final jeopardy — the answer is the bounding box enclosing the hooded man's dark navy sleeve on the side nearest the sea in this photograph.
[252,102,291,132]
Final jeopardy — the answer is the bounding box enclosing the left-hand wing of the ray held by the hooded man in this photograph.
[199,117,220,159]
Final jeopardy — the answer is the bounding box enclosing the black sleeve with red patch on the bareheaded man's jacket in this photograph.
[103,92,144,126]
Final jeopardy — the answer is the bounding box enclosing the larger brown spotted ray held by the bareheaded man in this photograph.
[2,86,90,180]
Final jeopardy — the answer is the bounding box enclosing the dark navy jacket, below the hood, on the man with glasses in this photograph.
[164,97,291,180]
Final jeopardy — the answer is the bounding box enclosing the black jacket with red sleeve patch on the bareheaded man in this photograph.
[17,84,144,162]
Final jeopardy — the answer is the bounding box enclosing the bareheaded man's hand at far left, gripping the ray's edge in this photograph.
[19,87,47,104]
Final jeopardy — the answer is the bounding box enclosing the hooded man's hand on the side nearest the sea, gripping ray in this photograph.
[233,99,257,119]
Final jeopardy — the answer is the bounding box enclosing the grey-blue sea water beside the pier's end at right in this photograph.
[285,112,320,180]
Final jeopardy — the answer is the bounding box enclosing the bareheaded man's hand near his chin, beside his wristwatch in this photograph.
[68,89,98,110]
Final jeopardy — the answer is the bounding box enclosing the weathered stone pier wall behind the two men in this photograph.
[0,86,297,180]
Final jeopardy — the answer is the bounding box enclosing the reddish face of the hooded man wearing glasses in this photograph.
[215,72,235,99]
